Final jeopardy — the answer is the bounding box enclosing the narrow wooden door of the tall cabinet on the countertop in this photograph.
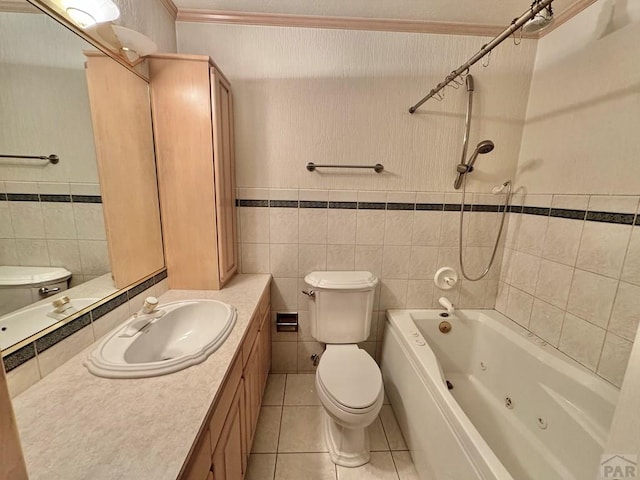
[211,68,238,285]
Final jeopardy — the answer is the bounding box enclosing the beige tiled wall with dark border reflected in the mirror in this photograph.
[0,182,110,286]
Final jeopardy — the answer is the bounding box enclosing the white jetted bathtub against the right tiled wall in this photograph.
[381,310,618,480]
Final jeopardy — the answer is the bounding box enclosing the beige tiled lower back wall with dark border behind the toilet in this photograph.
[238,188,502,373]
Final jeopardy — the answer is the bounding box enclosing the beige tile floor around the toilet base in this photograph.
[245,374,418,480]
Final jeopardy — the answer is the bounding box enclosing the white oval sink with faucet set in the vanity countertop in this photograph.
[85,300,237,378]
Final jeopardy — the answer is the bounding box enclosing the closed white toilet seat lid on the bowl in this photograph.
[316,345,383,414]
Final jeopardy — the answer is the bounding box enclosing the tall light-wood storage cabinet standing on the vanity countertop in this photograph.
[149,55,238,290]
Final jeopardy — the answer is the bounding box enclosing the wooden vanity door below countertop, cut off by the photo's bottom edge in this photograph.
[213,381,244,480]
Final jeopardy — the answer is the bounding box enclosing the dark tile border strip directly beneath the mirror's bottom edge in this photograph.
[2,268,167,372]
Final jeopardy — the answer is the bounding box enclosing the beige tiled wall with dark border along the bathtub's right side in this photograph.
[496,195,640,386]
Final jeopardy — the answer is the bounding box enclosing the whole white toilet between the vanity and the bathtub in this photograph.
[304,272,384,467]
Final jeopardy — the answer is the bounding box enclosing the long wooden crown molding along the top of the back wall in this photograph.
[176,8,516,37]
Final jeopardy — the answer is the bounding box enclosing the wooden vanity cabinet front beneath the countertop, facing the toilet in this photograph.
[180,288,271,480]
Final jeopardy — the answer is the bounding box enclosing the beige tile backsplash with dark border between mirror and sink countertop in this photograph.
[2,270,169,398]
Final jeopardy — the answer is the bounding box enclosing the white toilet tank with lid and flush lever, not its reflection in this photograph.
[304,272,378,344]
